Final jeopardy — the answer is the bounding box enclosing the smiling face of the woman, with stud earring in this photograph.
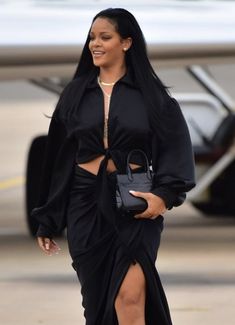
[89,18,131,68]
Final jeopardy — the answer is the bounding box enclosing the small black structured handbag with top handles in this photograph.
[116,149,153,213]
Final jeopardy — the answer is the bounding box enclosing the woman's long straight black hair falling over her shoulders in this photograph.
[73,8,169,133]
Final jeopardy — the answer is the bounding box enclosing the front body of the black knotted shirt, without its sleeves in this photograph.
[77,75,153,167]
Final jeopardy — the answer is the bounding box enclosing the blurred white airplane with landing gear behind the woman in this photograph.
[0,0,235,234]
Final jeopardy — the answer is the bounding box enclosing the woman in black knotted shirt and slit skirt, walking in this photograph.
[33,9,194,325]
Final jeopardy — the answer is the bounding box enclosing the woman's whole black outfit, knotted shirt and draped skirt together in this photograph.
[32,68,195,325]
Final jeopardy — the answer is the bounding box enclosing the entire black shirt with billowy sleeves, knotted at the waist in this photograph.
[32,74,195,236]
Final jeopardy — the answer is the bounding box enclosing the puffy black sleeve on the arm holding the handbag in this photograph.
[151,97,195,209]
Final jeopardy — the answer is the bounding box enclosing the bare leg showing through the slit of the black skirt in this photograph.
[115,264,146,325]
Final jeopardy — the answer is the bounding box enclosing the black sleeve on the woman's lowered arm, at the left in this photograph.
[31,83,77,237]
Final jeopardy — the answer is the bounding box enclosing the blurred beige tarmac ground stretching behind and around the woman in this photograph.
[0,64,235,325]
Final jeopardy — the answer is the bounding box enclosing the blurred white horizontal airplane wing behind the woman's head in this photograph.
[0,0,235,80]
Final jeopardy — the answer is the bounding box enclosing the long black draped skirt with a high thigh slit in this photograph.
[67,166,172,325]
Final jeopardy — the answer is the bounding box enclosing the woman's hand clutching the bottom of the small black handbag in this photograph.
[130,191,166,219]
